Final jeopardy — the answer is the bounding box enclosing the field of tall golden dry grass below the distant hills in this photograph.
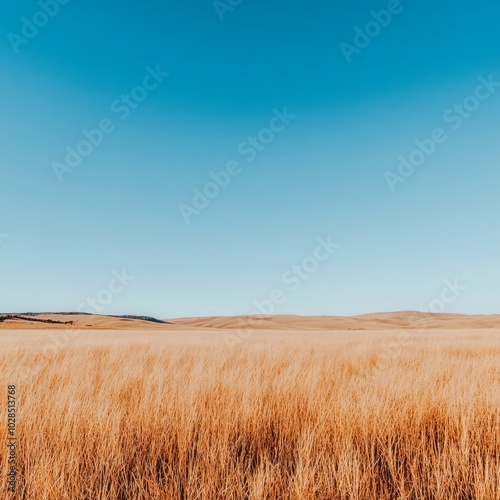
[0,330,500,500]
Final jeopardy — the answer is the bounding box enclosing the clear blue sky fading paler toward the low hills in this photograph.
[0,0,500,317]
